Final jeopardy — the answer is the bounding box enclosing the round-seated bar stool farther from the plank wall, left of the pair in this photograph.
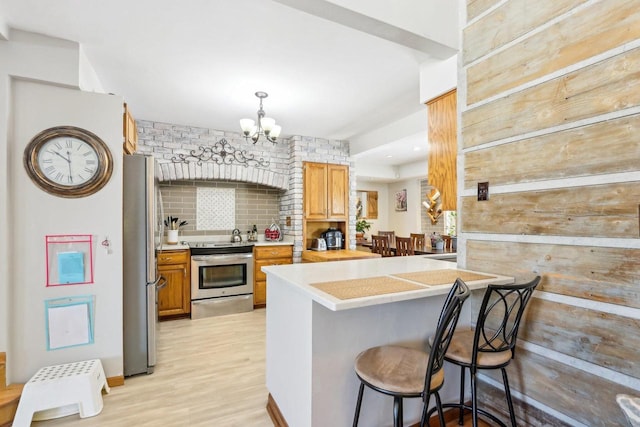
[353,279,470,427]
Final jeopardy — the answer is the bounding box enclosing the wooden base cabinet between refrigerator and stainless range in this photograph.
[158,250,191,319]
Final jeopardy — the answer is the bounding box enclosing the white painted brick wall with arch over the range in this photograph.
[136,120,356,262]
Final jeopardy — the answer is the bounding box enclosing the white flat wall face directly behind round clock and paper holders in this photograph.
[8,81,123,382]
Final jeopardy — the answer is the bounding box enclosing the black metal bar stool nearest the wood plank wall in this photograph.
[430,276,540,427]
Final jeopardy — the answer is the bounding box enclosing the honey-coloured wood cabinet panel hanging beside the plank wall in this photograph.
[427,89,458,211]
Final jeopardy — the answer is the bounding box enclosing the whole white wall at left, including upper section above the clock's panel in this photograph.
[0,32,123,382]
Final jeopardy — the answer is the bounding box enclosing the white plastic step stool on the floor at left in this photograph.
[13,359,109,427]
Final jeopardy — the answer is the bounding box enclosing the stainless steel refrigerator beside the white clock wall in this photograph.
[122,154,164,376]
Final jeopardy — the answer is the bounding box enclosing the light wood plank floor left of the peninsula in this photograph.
[33,309,273,427]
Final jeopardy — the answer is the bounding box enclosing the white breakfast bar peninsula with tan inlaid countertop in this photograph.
[262,256,513,427]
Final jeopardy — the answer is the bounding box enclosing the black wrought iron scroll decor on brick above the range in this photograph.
[171,139,269,168]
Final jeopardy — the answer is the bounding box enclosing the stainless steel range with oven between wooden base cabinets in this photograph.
[189,242,253,319]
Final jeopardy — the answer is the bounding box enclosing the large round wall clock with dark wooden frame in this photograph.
[23,126,113,198]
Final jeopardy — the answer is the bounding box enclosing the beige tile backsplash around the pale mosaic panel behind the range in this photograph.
[160,181,281,236]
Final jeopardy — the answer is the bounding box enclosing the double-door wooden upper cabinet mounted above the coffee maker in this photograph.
[303,162,349,221]
